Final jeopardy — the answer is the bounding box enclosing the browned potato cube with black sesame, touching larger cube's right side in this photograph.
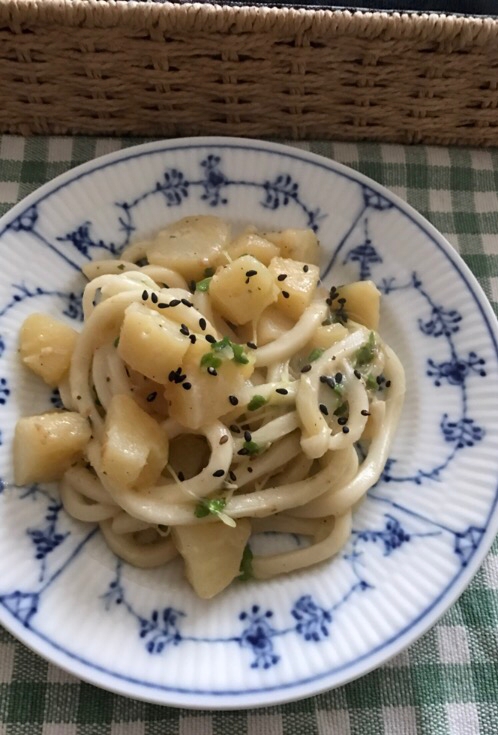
[268,258,320,321]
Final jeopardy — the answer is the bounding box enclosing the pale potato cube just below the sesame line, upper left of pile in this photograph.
[118,303,190,384]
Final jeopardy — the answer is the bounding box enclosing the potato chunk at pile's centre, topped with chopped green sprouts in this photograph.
[165,340,254,429]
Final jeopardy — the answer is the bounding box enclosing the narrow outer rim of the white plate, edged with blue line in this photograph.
[0,136,498,710]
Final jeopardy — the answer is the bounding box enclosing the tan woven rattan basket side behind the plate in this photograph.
[0,0,498,145]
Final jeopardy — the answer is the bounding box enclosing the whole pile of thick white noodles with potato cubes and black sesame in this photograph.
[14,216,404,597]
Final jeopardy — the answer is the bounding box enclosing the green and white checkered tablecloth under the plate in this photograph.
[0,136,498,735]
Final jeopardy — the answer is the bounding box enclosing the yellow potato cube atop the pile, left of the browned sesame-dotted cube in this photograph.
[209,255,279,324]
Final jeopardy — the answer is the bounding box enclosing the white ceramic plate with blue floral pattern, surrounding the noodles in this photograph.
[0,138,498,708]
